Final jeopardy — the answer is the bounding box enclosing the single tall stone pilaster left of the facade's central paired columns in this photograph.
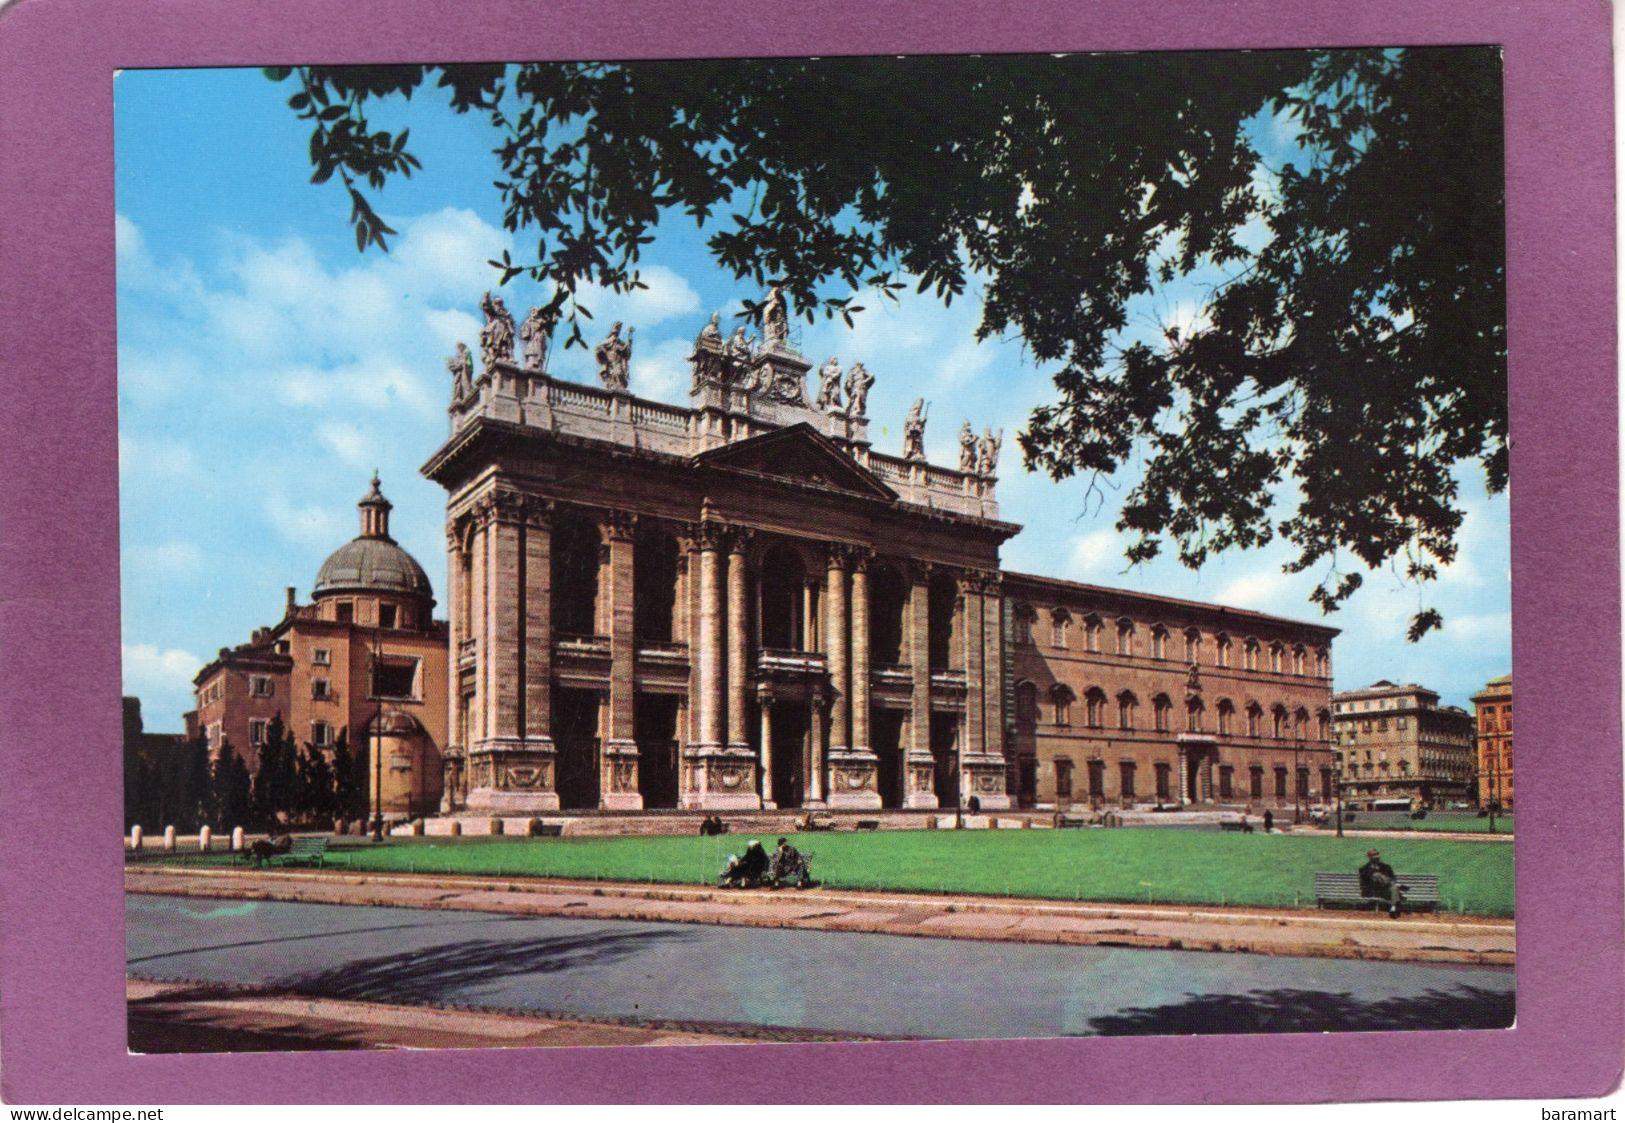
[598,510,644,811]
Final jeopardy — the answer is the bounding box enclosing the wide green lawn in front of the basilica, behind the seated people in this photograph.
[136,829,1513,917]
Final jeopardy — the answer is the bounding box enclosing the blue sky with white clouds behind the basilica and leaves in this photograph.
[114,70,1511,730]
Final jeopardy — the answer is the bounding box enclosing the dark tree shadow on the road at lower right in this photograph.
[1089,985,1516,1037]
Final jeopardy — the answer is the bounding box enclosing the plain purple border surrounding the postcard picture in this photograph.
[0,0,1625,1103]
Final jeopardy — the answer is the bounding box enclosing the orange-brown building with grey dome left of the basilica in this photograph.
[187,476,449,817]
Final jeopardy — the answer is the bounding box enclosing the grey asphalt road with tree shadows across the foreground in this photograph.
[125,894,1513,1038]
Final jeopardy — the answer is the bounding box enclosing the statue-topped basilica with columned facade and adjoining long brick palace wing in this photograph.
[423,291,1336,814]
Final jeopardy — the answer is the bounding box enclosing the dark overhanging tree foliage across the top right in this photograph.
[267,49,1506,639]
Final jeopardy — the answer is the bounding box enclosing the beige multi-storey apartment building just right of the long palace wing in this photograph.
[1333,679,1476,808]
